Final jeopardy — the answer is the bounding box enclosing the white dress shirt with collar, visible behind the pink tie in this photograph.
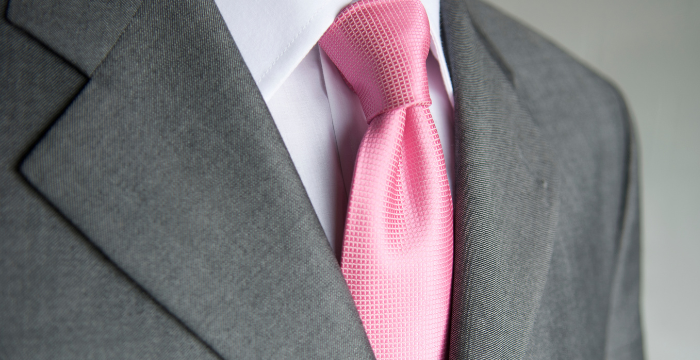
[215,0,454,256]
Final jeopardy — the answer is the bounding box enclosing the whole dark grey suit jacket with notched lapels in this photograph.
[0,0,642,359]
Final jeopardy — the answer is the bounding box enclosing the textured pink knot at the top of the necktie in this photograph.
[319,0,430,122]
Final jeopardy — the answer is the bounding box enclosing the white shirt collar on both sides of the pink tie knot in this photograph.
[215,0,452,101]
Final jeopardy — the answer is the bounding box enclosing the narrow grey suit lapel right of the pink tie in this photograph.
[441,0,559,359]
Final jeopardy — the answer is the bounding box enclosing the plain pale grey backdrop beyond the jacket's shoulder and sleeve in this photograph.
[488,0,700,360]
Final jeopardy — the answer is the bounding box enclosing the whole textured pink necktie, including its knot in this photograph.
[320,0,453,360]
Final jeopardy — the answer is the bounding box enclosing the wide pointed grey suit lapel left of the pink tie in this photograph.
[21,0,373,359]
